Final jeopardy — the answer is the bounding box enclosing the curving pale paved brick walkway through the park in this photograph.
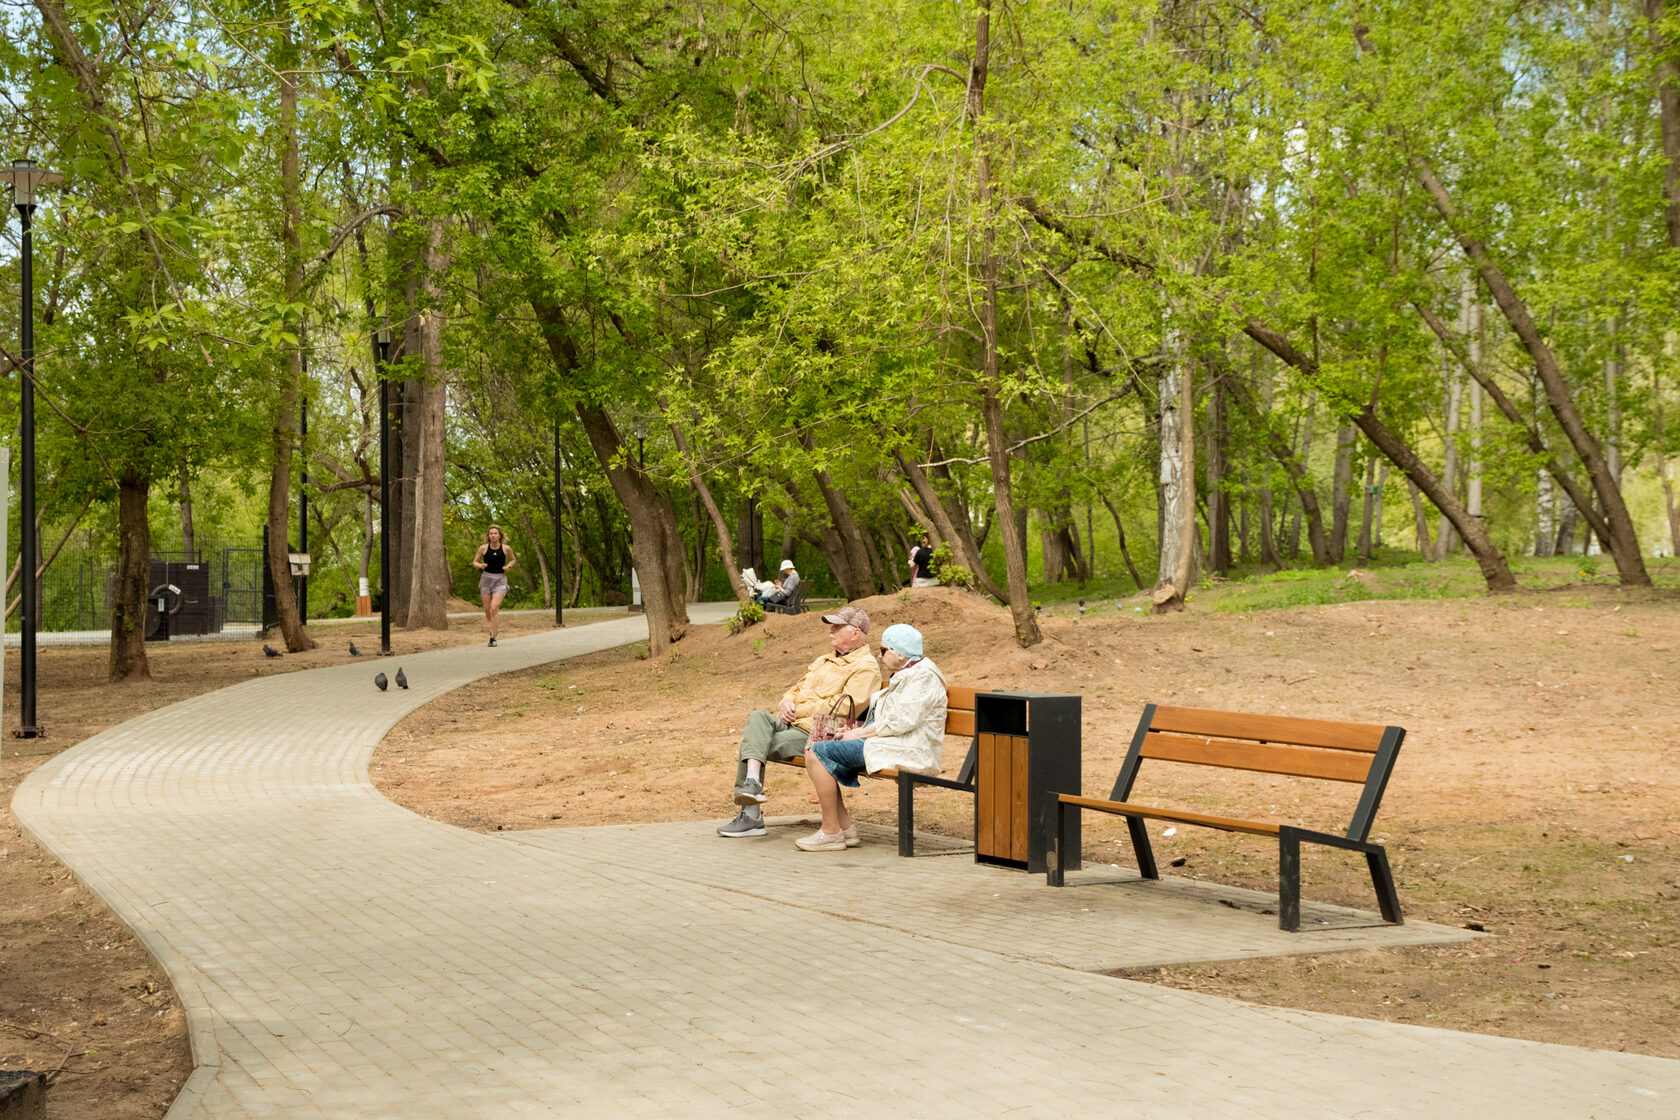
[13,620,1680,1120]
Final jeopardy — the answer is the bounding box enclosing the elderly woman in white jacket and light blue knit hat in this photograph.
[793,623,946,851]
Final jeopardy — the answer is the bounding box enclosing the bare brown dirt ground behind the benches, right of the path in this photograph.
[373,588,1680,1058]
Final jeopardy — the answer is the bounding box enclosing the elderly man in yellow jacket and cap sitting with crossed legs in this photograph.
[717,606,887,836]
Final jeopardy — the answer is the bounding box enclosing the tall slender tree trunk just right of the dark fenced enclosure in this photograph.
[263,18,314,653]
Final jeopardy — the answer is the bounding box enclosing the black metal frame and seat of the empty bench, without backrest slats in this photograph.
[1045,704,1406,934]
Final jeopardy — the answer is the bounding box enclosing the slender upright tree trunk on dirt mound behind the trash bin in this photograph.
[968,0,1043,646]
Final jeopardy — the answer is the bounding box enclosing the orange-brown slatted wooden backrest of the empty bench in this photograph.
[1109,704,1406,841]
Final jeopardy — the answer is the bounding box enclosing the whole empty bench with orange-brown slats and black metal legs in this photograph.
[1047,704,1406,932]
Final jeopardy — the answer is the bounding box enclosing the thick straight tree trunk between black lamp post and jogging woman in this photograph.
[403,220,450,630]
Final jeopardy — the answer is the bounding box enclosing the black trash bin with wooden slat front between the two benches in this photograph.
[974,692,1084,873]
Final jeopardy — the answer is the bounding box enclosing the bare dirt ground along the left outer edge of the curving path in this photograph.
[0,603,601,1120]
